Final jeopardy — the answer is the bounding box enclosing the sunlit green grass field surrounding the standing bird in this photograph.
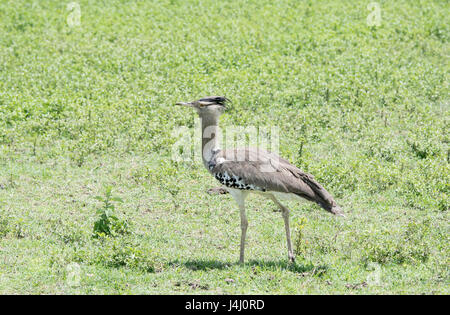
[0,0,450,294]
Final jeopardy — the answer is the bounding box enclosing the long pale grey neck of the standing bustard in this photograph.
[201,115,220,168]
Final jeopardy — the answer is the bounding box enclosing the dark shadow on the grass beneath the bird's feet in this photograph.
[169,259,328,274]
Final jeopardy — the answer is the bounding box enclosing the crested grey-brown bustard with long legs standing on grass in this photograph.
[176,96,344,264]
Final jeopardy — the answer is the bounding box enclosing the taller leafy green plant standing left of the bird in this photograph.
[93,186,129,238]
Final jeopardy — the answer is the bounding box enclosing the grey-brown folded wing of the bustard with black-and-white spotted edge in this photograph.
[211,149,336,211]
